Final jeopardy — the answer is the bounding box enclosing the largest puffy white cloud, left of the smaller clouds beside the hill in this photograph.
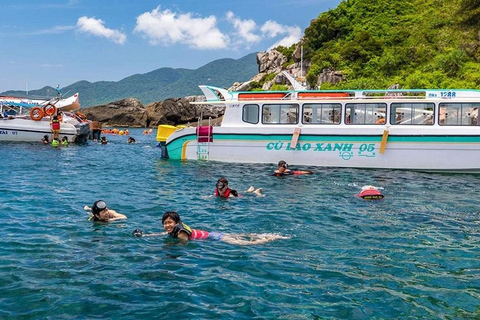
[134,6,230,49]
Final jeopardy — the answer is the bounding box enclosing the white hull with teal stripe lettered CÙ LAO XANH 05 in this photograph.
[167,126,480,173]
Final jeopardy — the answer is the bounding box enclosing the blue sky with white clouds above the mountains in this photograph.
[0,0,341,92]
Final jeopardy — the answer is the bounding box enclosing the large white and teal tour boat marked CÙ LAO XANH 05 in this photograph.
[157,75,480,172]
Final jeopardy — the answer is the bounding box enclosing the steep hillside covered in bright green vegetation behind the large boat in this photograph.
[303,0,480,89]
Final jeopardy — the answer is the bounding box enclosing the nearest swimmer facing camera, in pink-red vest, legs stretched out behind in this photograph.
[133,211,289,245]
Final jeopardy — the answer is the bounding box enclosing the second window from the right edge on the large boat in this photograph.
[390,102,435,125]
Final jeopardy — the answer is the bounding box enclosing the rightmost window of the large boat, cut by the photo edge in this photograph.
[438,103,480,126]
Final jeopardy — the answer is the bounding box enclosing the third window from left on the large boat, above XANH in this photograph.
[303,103,342,124]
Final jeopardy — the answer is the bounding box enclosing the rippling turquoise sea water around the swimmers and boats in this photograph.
[0,129,480,319]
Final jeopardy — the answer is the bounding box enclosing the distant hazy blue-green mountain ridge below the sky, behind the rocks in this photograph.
[0,53,258,107]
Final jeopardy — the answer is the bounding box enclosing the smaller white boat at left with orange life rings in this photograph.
[0,93,90,142]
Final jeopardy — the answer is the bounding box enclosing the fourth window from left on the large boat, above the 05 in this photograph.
[345,103,387,125]
